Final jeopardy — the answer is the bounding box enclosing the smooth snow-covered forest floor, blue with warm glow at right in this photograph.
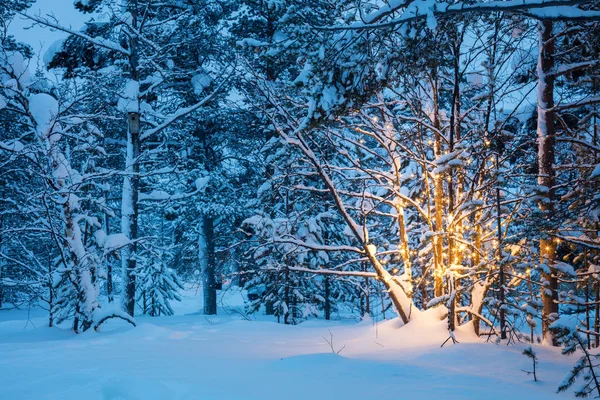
[0,290,574,400]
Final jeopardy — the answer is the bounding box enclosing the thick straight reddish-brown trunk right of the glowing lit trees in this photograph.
[537,21,558,345]
